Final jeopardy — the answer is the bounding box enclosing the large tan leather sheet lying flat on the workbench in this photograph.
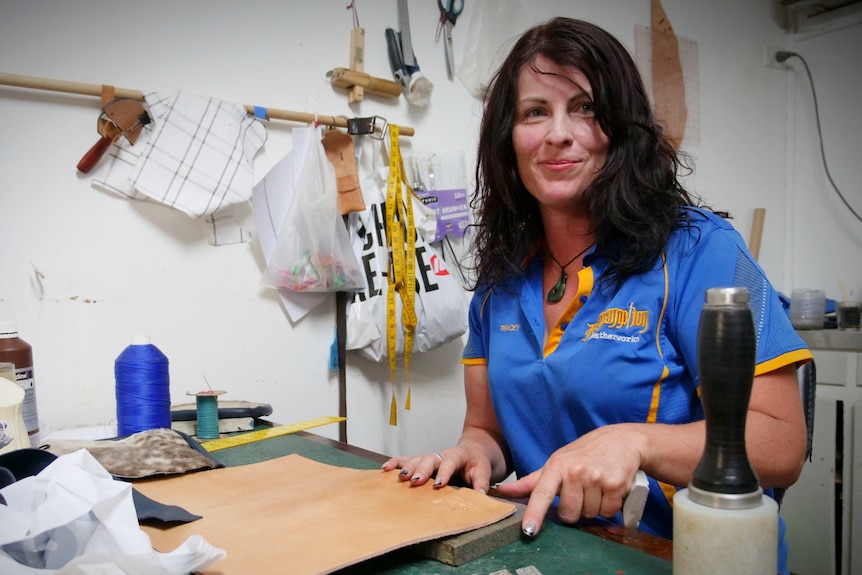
[135,455,515,575]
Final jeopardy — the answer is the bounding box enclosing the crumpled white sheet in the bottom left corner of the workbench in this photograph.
[0,449,225,575]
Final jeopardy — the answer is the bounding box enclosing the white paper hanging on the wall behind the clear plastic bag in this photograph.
[251,127,330,321]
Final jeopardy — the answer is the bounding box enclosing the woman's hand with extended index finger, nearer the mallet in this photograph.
[497,424,643,536]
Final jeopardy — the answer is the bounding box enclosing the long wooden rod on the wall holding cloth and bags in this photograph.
[0,72,414,136]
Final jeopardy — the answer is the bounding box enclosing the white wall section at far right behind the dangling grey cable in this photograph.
[787,11,862,299]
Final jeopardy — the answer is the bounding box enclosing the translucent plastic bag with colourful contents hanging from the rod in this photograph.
[261,129,365,292]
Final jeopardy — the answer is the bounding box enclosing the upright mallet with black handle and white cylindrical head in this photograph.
[673,287,778,575]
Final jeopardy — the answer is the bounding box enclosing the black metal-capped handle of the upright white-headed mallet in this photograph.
[691,288,760,502]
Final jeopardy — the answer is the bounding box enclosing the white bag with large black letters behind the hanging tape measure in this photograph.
[347,168,469,361]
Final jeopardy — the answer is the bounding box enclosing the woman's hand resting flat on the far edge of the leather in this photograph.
[383,446,491,493]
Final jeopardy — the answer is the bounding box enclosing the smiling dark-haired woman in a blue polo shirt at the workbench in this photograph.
[383,18,811,570]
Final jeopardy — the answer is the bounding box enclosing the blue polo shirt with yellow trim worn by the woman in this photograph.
[462,208,812,560]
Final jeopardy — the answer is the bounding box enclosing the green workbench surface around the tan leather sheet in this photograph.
[212,435,673,575]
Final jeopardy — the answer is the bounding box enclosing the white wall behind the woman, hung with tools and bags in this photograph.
[0,0,862,460]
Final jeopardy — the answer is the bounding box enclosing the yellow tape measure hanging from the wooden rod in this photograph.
[386,124,417,425]
